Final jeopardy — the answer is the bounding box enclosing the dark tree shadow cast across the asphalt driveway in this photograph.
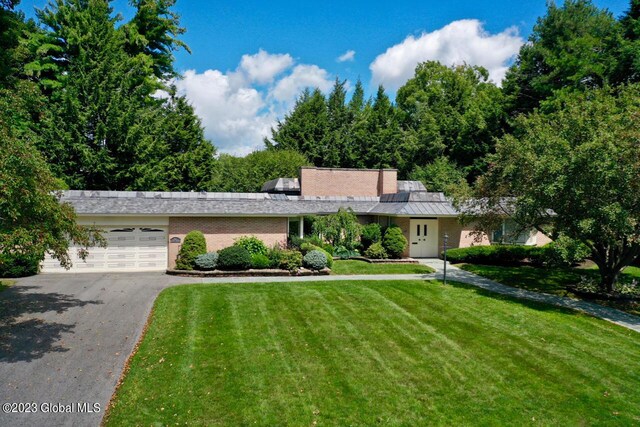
[0,285,102,363]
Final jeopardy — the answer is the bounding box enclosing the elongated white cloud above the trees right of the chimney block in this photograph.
[369,19,524,91]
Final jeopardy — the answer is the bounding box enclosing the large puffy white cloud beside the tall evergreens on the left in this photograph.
[175,50,332,155]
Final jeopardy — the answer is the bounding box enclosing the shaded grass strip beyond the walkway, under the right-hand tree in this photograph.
[458,264,640,315]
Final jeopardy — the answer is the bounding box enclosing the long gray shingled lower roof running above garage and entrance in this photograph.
[61,190,458,216]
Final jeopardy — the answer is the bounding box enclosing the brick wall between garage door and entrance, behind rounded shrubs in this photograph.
[169,217,288,268]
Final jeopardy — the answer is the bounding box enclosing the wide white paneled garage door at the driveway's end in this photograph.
[42,225,167,273]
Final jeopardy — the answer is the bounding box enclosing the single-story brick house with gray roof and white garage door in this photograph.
[43,167,548,272]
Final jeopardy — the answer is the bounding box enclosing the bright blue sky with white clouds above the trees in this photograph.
[20,0,629,154]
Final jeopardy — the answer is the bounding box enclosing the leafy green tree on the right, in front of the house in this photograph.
[471,85,640,291]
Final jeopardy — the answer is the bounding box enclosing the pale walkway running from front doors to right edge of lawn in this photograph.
[419,259,640,332]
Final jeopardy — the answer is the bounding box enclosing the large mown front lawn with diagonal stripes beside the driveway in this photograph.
[106,281,640,425]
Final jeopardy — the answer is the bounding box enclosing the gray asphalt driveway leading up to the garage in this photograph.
[0,273,201,426]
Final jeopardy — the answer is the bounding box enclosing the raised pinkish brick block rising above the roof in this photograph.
[300,167,398,196]
